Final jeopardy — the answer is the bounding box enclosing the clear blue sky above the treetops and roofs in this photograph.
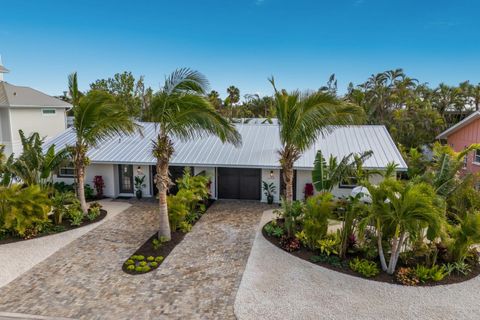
[0,0,480,95]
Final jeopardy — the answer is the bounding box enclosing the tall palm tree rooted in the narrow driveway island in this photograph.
[144,68,241,239]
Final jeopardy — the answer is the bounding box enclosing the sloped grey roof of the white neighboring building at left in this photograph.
[0,81,72,108]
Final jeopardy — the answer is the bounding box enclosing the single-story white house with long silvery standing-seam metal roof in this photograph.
[45,123,407,201]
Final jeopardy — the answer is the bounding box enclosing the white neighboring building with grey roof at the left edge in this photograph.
[0,60,72,156]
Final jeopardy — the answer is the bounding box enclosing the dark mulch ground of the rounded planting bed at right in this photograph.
[262,219,480,286]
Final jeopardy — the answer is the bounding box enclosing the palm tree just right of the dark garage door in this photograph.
[269,78,364,201]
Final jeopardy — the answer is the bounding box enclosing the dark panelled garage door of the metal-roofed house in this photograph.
[217,168,262,200]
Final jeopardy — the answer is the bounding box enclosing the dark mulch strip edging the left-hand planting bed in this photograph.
[0,209,107,245]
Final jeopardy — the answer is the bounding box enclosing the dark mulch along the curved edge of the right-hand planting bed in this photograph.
[262,223,480,287]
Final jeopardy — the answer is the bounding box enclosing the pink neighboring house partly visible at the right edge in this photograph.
[437,111,480,173]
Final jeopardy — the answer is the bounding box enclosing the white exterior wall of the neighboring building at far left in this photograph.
[9,107,67,155]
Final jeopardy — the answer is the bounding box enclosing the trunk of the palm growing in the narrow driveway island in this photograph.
[157,160,171,240]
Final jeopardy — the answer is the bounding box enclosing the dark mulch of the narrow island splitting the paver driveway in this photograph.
[122,199,215,275]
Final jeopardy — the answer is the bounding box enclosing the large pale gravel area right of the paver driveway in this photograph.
[235,211,480,320]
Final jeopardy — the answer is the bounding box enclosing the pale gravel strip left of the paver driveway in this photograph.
[0,200,130,287]
